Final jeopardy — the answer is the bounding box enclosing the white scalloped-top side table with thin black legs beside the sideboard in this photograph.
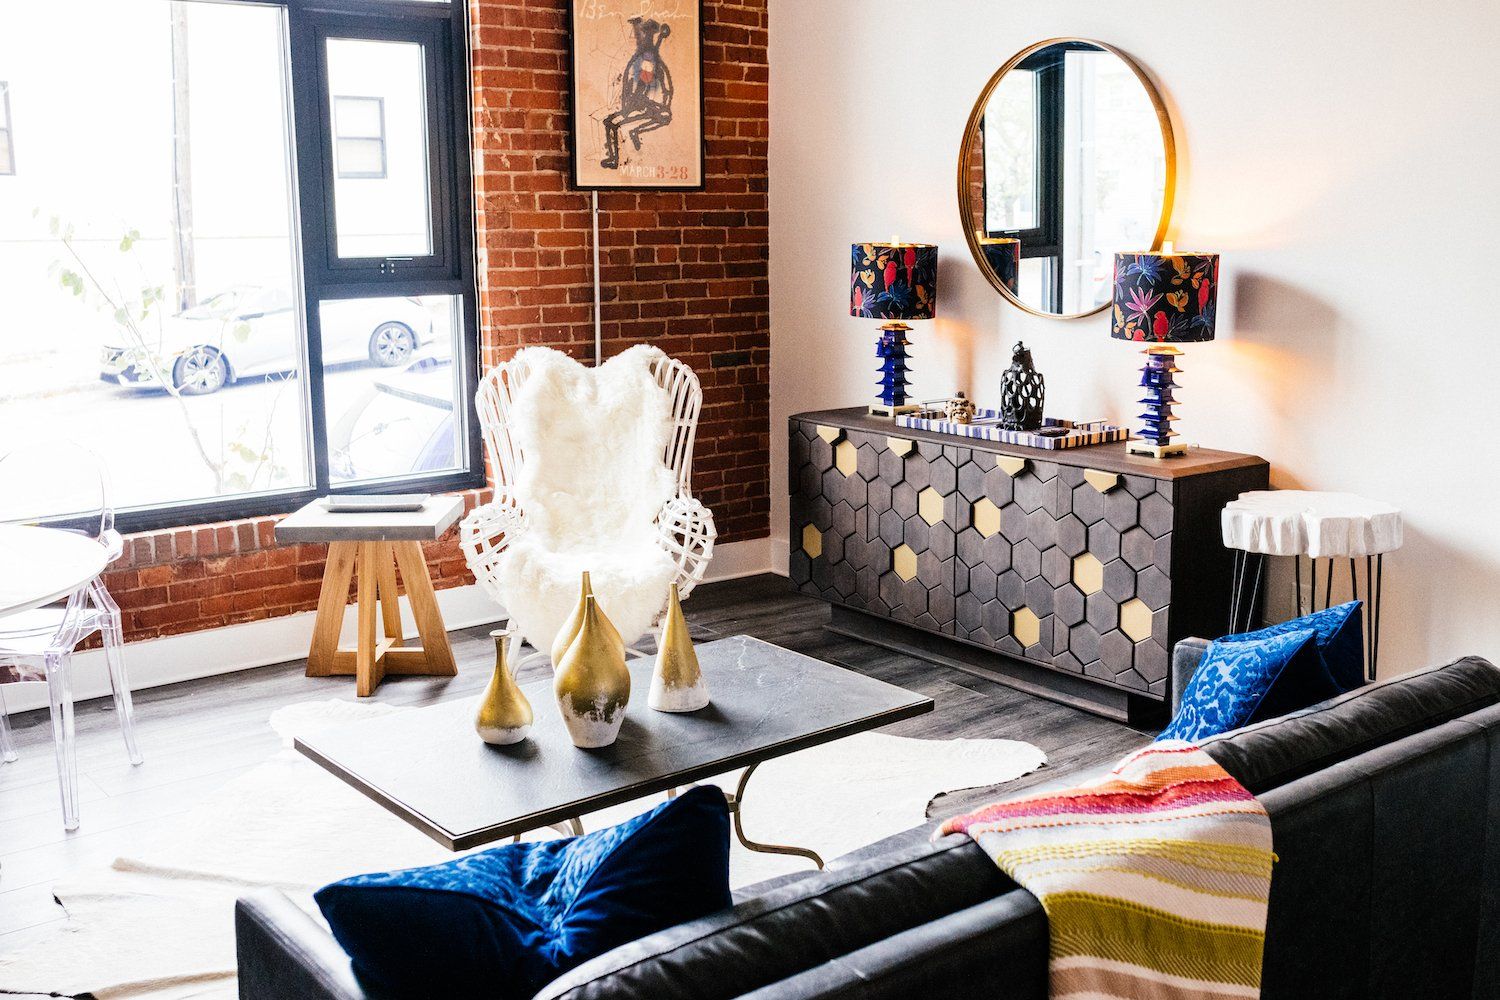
[1223,490,1403,681]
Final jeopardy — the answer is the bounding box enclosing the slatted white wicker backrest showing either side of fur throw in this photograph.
[474,354,704,496]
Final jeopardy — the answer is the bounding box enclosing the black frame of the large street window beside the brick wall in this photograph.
[51,0,488,532]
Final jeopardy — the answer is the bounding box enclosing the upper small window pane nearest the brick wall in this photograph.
[329,37,432,258]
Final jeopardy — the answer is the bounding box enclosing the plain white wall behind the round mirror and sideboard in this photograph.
[771,0,1500,676]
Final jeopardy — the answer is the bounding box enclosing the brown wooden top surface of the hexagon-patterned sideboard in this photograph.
[792,406,1266,480]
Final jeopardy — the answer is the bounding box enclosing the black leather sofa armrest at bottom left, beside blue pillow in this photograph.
[234,889,374,1000]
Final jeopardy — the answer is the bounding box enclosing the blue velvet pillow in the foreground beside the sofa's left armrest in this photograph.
[315,786,731,1000]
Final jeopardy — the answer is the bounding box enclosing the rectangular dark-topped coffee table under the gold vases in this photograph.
[294,636,933,868]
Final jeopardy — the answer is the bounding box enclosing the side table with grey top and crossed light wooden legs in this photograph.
[276,496,464,697]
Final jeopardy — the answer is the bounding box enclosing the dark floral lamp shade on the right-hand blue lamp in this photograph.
[1110,250,1218,343]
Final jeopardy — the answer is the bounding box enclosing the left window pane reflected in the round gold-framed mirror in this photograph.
[984,69,1040,232]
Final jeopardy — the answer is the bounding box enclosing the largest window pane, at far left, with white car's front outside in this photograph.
[0,0,312,507]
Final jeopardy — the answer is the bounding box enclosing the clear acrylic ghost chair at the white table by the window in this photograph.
[0,442,141,831]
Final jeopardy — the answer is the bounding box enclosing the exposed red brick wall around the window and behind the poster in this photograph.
[105,0,770,639]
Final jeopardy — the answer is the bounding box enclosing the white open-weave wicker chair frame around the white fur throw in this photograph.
[459,354,719,650]
